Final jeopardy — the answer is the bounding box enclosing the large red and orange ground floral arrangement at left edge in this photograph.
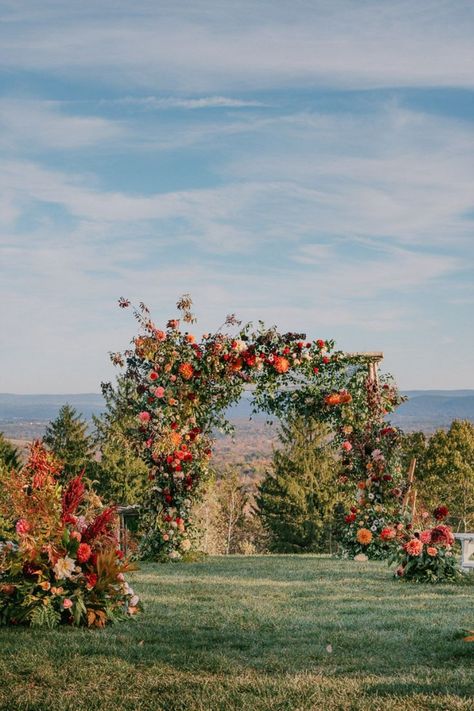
[0,443,140,627]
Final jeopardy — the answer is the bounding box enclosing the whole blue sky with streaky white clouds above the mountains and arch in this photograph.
[0,0,474,393]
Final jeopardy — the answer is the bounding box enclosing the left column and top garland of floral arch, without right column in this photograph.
[115,297,378,559]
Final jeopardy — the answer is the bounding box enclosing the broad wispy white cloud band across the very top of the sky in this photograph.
[0,0,474,91]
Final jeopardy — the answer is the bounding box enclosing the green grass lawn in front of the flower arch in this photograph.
[0,555,474,711]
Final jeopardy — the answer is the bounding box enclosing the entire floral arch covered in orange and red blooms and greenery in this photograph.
[115,296,408,560]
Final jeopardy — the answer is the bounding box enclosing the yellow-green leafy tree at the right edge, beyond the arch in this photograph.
[416,420,474,531]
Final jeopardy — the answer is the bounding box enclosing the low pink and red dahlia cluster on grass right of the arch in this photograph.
[390,506,462,583]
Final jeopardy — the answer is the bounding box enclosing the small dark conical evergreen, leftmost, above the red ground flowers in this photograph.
[43,404,93,479]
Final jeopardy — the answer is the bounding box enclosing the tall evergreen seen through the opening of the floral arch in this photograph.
[257,417,341,553]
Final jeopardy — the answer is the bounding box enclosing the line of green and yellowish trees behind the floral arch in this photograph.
[0,394,474,554]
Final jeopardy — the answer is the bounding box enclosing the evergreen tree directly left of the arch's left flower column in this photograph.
[93,377,148,505]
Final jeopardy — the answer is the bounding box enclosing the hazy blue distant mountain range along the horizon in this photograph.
[0,390,474,439]
